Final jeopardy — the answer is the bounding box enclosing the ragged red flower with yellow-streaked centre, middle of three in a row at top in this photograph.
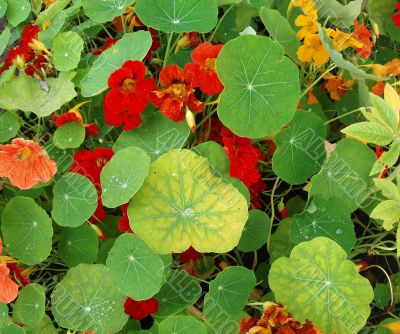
[150,65,204,122]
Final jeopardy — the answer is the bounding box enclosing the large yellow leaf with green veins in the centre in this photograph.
[128,150,248,254]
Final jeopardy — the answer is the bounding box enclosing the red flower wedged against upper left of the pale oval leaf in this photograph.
[70,147,114,190]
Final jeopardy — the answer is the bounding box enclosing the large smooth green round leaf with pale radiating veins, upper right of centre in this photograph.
[217,35,300,138]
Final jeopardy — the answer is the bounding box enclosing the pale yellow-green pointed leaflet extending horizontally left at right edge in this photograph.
[342,122,395,146]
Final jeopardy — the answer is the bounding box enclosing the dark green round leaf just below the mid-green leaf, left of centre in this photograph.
[58,224,99,267]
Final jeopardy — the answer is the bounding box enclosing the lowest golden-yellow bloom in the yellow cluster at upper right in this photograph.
[297,34,329,66]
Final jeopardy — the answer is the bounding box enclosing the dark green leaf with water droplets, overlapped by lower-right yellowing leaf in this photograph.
[290,197,356,253]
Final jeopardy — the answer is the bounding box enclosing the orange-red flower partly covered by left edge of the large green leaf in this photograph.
[185,42,224,95]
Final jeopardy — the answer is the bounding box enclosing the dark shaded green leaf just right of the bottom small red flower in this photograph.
[155,270,202,317]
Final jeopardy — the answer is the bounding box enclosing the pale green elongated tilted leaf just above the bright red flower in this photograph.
[80,31,152,97]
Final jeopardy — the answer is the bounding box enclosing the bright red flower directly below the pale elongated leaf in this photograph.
[103,60,156,130]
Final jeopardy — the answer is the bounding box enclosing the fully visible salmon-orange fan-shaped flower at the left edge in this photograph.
[0,138,57,189]
